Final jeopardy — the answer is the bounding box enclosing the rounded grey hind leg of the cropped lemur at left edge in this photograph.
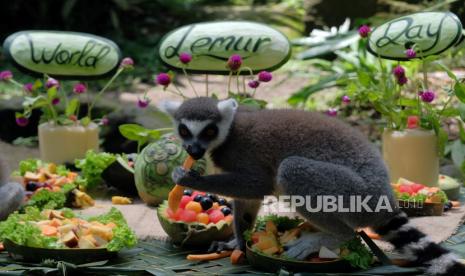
[0,182,24,221]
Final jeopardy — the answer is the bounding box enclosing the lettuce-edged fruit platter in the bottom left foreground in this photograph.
[0,207,137,263]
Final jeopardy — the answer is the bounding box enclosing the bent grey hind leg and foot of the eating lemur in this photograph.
[277,156,390,259]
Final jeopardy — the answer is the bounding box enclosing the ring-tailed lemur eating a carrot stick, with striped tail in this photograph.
[160,97,465,275]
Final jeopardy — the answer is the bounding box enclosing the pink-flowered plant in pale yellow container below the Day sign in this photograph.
[328,26,465,186]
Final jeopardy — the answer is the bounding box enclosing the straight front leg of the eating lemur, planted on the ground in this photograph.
[208,199,262,252]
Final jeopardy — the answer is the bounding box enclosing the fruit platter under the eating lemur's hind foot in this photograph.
[244,215,373,272]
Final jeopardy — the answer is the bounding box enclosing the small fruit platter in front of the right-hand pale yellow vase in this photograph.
[391,178,460,217]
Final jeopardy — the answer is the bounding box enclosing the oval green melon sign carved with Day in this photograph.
[367,12,462,60]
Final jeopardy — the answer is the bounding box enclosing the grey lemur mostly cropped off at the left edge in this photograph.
[0,159,24,221]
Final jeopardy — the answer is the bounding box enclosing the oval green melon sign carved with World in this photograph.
[3,31,121,79]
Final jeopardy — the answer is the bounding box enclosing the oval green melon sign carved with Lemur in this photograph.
[159,21,291,74]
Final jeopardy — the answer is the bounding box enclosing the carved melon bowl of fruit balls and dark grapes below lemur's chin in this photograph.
[157,189,233,247]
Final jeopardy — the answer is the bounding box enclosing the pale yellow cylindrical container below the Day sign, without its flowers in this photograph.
[383,129,439,187]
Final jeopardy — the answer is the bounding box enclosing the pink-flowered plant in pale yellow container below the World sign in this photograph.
[0,58,134,164]
